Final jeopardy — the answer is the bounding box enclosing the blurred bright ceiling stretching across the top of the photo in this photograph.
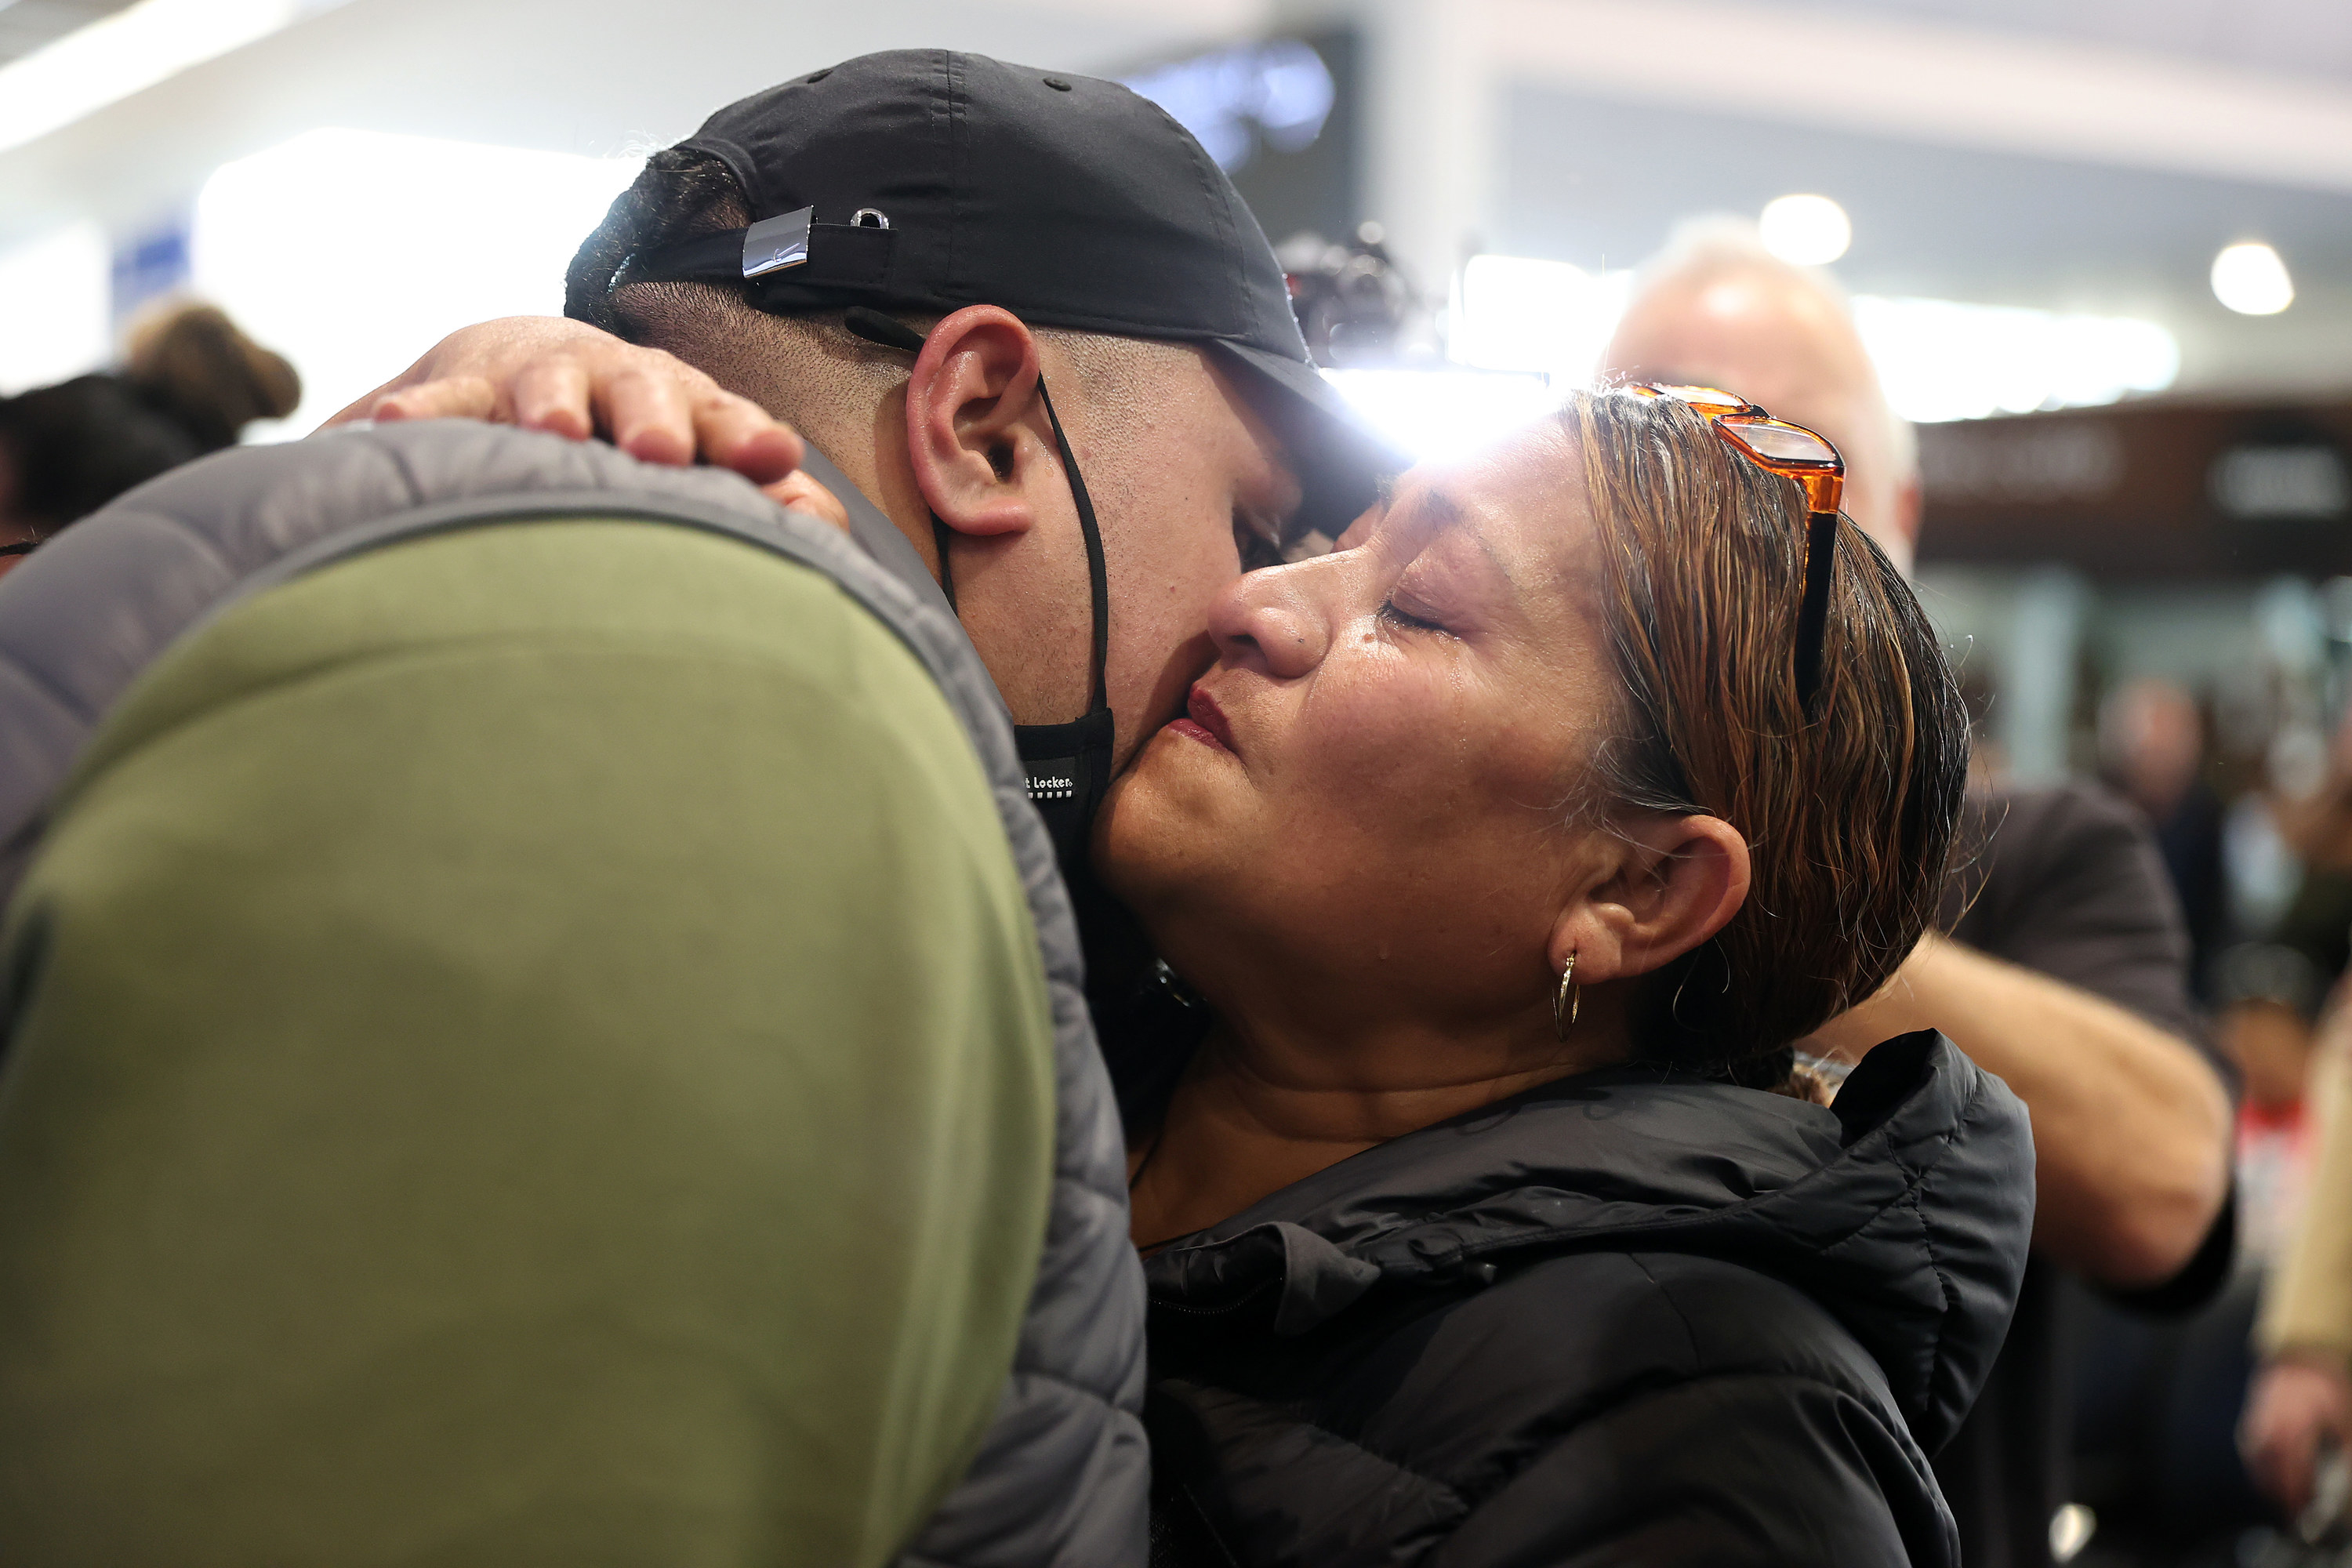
[0,0,2352,390]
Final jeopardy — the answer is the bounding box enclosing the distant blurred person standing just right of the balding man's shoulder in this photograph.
[2098,677,2230,999]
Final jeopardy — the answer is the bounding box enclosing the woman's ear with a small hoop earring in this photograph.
[1550,815,1748,982]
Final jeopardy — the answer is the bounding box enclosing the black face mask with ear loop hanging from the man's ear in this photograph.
[842,306,1117,891]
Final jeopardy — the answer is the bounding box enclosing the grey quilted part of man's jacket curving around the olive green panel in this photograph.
[0,421,1148,1568]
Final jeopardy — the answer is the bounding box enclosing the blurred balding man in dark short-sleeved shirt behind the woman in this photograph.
[1604,221,2232,1568]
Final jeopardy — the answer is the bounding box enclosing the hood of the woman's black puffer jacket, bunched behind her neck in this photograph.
[1145,1032,2034,1453]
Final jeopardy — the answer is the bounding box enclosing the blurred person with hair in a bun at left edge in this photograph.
[0,303,301,583]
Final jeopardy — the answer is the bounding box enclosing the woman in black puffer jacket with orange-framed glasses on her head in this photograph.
[1096,390,2032,1568]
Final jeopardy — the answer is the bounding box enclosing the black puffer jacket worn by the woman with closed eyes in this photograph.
[1145,1034,2032,1568]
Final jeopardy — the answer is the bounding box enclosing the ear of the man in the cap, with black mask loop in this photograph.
[906,306,1058,536]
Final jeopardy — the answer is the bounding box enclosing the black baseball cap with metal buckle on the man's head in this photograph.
[614,49,1404,536]
